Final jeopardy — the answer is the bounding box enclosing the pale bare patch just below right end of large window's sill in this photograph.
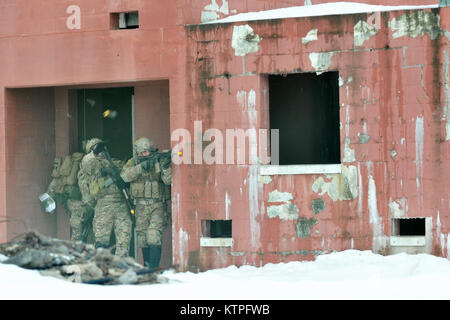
[312,166,358,201]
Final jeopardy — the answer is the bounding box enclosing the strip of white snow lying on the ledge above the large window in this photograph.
[203,1,438,24]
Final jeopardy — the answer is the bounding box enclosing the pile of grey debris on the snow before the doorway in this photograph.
[0,232,167,285]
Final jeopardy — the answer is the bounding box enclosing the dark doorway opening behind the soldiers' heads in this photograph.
[77,87,134,161]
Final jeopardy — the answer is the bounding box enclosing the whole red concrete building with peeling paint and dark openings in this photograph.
[0,0,450,271]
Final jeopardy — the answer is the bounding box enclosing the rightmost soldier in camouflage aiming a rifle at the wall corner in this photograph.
[121,138,172,268]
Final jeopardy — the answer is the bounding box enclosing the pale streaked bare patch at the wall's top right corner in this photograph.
[389,10,443,40]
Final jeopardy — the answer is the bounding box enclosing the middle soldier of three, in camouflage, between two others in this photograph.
[79,138,132,256]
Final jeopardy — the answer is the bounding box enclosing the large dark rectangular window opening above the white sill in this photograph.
[269,71,341,165]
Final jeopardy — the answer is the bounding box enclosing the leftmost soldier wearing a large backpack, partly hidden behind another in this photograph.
[47,148,93,242]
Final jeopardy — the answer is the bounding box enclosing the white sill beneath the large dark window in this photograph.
[260,164,342,176]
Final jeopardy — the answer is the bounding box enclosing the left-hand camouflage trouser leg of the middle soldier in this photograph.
[93,199,114,248]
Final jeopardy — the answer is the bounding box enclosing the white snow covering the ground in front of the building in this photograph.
[0,250,450,300]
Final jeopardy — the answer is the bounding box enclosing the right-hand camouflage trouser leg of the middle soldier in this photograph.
[114,202,132,257]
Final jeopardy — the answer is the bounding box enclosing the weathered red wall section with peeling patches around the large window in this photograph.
[173,9,450,270]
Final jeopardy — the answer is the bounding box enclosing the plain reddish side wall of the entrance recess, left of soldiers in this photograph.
[5,88,56,239]
